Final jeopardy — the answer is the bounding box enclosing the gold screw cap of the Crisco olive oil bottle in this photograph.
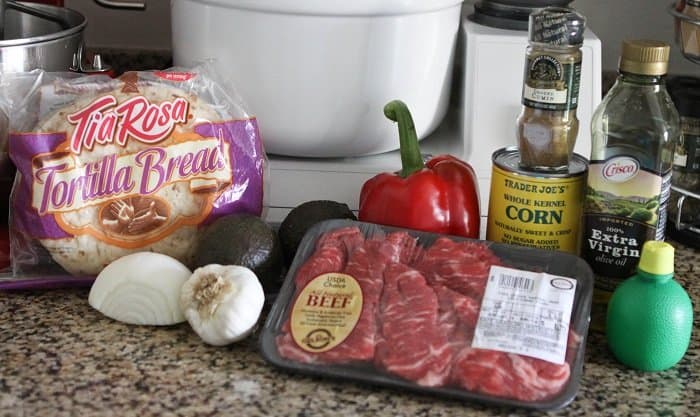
[620,40,671,75]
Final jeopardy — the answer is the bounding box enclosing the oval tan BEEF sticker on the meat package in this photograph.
[290,272,363,352]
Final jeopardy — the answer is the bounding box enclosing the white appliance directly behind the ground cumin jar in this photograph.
[460,13,602,182]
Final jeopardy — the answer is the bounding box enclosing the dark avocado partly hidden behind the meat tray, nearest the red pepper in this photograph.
[278,200,357,266]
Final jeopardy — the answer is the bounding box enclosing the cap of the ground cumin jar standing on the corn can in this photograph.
[528,7,586,46]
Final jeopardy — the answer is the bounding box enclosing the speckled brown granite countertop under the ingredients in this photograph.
[0,243,700,417]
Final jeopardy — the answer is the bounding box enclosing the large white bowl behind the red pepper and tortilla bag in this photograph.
[171,0,462,157]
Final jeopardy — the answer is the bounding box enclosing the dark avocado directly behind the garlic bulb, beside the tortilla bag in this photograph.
[193,214,284,293]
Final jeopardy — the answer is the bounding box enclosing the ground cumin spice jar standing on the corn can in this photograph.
[517,7,586,171]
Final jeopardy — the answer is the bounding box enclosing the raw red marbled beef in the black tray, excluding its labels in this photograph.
[276,228,581,402]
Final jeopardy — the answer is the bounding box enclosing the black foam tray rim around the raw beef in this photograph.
[259,220,593,411]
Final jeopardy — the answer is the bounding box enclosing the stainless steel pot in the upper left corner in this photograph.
[0,0,87,72]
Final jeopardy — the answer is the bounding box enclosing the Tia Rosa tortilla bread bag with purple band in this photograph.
[1,65,267,286]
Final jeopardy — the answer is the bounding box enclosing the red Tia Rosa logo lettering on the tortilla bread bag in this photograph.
[66,95,189,154]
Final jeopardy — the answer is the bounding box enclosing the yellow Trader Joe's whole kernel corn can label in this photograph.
[486,151,585,254]
